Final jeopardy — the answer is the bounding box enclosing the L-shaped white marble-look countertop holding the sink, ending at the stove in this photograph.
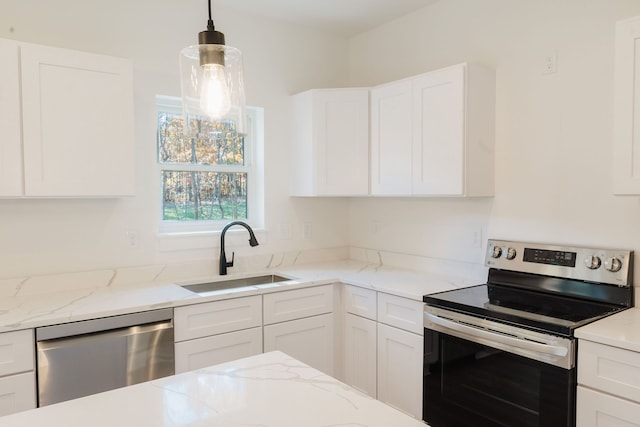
[0,261,480,332]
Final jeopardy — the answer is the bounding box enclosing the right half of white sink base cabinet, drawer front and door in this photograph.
[263,285,335,375]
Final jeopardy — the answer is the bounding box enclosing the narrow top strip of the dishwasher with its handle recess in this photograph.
[36,308,173,342]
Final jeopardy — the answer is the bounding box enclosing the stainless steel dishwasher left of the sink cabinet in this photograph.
[36,308,175,406]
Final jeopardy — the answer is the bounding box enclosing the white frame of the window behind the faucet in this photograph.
[154,95,264,236]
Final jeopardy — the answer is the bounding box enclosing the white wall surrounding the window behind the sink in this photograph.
[0,0,348,278]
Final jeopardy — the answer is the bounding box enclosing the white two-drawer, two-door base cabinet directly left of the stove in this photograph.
[342,285,424,419]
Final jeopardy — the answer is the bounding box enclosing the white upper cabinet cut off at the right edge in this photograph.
[613,17,640,194]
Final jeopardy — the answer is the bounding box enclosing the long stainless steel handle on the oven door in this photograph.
[424,313,569,357]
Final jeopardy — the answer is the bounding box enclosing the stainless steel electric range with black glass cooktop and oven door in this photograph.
[423,240,633,427]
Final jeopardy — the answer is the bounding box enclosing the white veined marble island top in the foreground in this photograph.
[0,352,425,427]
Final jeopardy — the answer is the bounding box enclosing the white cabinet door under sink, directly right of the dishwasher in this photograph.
[175,328,262,374]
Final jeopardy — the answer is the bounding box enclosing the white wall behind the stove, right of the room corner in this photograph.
[350,0,640,274]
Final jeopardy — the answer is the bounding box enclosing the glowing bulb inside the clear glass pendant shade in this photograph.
[200,64,231,119]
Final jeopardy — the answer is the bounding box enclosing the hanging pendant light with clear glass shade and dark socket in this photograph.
[180,0,245,134]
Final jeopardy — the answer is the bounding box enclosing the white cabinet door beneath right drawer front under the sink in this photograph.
[264,314,334,376]
